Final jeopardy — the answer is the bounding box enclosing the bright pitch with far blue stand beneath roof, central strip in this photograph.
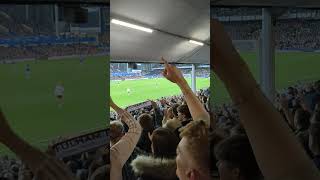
[110,63,210,108]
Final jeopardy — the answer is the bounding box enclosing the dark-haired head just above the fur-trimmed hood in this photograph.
[151,128,179,158]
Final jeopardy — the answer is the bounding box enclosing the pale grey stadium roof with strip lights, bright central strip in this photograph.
[110,0,210,64]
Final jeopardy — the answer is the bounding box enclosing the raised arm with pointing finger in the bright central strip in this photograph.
[162,58,210,126]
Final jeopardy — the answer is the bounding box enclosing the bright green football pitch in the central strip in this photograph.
[110,78,210,108]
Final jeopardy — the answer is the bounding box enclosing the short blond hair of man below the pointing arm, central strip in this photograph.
[179,120,210,171]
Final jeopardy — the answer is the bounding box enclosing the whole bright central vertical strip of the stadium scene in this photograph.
[110,0,211,180]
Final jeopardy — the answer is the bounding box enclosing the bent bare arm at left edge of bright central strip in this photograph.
[110,98,142,167]
